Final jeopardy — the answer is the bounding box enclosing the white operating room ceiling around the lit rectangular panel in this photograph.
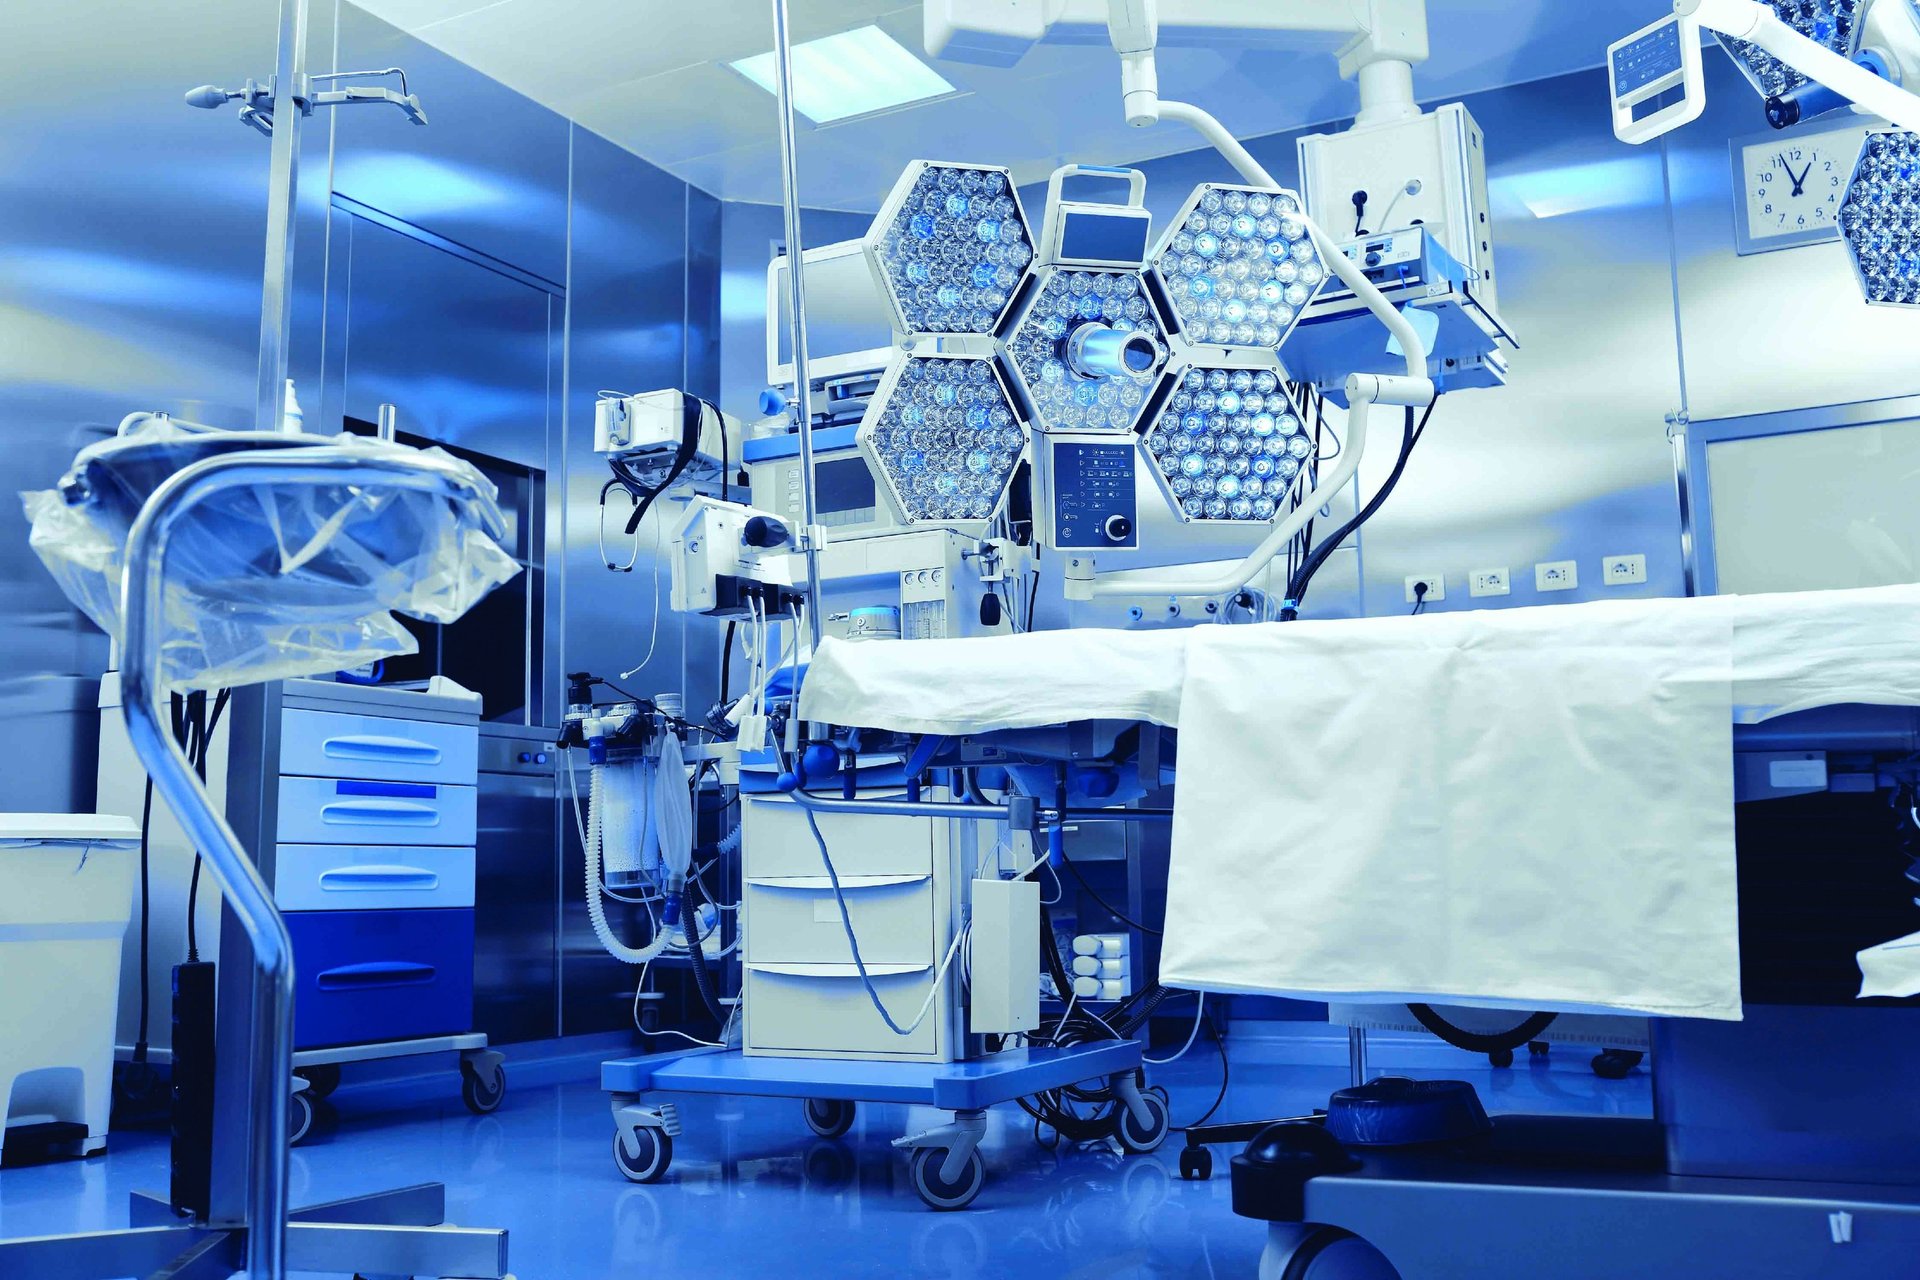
[355,0,1665,211]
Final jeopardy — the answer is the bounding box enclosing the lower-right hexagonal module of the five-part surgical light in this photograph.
[1146,365,1313,522]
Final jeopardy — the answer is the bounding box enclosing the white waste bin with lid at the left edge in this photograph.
[0,814,140,1155]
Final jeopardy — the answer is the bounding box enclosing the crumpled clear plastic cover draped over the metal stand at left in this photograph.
[21,418,520,689]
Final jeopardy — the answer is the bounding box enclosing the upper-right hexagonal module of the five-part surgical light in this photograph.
[1152,182,1327,351]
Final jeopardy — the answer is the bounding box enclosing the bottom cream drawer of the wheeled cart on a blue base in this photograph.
[745,967,936,1057]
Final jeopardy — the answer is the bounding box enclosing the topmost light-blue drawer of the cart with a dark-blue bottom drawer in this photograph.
[280,708,480,783]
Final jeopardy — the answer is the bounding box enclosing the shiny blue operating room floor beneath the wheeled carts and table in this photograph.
[0,1046,1647,1280]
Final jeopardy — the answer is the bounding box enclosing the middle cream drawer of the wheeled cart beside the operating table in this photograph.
[743,873,933,965]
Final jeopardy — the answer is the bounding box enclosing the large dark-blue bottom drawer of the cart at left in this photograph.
[286,910,474,1050]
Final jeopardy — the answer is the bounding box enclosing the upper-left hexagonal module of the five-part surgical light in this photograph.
[866,159,1033,334]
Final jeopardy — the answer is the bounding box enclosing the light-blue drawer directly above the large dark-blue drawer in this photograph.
[273,844,474,912]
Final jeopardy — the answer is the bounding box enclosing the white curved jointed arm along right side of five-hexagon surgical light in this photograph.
[1069,102,1436,599]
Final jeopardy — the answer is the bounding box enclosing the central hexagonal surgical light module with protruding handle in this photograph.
[1006,267,1167,432]
